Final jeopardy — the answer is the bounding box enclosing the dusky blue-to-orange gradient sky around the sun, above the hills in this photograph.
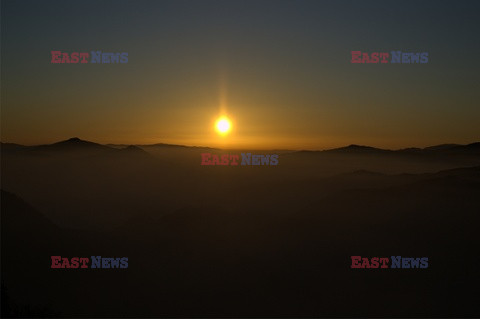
[1,0,480,149]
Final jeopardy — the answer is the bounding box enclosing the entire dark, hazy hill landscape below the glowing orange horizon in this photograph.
[1,138,480,317]
